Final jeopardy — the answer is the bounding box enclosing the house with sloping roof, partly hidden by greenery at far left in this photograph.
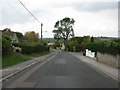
[2,28,19,43]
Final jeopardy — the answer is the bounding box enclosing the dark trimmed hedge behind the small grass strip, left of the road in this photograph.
[21,44,49,54]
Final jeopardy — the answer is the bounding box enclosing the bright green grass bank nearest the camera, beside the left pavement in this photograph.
[2,53,31,68]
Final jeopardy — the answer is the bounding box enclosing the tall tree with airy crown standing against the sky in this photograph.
[53,17,75,50]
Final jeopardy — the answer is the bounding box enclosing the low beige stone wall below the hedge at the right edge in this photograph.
[97,52,120,68]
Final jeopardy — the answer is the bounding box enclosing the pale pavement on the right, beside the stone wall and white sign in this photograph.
[69,52,119,80]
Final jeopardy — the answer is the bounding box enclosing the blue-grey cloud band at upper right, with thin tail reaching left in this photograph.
[55,2,118,12]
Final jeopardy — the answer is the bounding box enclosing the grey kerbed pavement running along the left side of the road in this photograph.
[0,52,55,81]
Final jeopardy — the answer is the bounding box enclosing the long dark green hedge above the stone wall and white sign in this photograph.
[84,42,120,55]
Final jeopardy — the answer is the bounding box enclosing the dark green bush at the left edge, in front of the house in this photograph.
[2,35,12,56]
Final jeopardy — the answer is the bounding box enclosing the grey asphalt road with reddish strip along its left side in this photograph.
[3,51,118,88]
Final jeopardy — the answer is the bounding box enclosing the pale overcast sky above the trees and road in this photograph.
[0,0,118,38]
